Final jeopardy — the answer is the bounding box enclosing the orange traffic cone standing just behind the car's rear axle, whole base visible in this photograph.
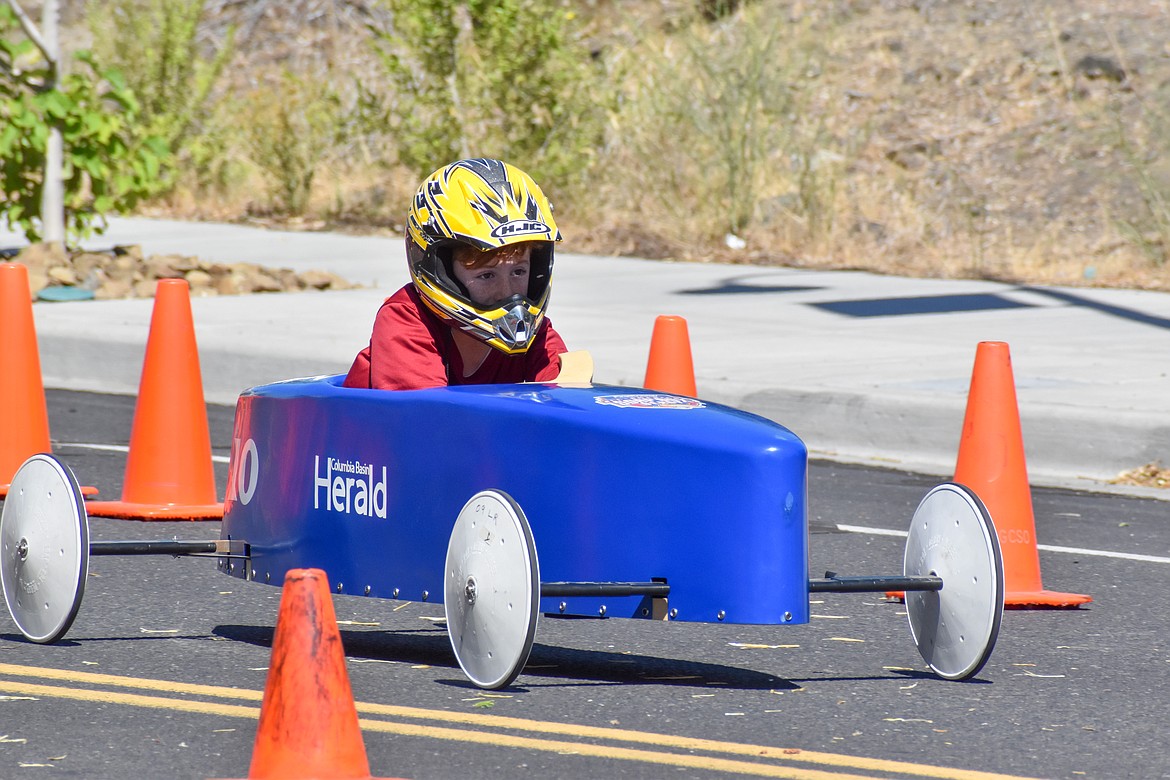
[85,279,223,520]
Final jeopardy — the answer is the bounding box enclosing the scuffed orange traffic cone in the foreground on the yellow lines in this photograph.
[235,568,404,780]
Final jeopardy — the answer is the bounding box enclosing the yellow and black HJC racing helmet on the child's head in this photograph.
[406,159,560,354]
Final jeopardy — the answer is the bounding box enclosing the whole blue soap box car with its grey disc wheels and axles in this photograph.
[0,359,1004,688]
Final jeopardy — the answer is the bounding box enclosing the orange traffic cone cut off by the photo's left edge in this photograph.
[0,263,97,498]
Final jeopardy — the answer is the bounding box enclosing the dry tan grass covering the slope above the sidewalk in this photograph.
[66,0,1170,290]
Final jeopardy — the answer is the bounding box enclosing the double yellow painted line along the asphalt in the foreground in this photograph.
[0,663,1043,780]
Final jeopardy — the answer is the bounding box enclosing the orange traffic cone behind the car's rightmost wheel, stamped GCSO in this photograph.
[955,341,1093,607]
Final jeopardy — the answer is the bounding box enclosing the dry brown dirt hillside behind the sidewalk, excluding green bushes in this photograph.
[27,0,1170,290]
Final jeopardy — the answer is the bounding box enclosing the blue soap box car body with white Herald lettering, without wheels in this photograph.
[222,377,808,623]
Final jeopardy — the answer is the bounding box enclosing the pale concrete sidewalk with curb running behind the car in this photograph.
[0,219,1170,498]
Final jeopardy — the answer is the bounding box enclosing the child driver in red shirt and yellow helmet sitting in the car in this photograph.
[344,159,567,389]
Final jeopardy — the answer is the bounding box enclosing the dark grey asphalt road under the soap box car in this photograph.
[0,391,1170,780]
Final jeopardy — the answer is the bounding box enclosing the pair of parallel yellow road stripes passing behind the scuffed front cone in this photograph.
[0,663,1043,780]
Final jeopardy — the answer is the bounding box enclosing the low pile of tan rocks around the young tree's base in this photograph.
[4,243,358,301]
